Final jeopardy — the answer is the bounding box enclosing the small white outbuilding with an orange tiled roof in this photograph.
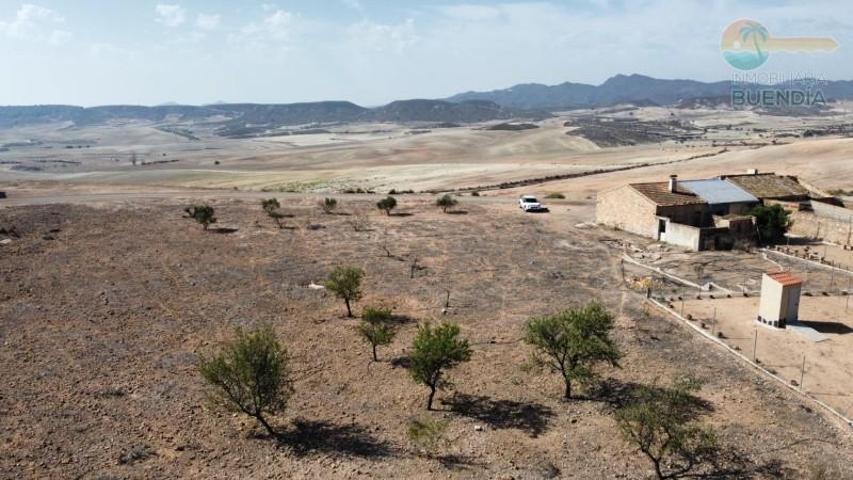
[758,272,803,328]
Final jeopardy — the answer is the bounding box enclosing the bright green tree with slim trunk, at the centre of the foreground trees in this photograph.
[409,322,471,410]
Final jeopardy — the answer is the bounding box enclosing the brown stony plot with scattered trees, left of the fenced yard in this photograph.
[0,196,853,479]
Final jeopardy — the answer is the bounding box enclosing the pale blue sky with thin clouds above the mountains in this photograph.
[0,0,853,105]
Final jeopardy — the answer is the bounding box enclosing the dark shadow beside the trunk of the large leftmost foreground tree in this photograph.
[277,420,394,458]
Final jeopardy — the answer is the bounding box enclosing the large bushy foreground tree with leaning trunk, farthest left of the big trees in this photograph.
[198,325,292,436]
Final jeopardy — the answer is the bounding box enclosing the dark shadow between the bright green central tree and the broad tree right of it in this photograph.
[441,393,554,437]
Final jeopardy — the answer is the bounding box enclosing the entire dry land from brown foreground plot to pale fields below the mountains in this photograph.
[0,103,853,480]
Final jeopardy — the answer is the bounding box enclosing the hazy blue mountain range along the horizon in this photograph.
[5,75,853,137]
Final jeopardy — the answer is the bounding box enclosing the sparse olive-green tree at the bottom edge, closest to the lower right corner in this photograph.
[616,378,717,479]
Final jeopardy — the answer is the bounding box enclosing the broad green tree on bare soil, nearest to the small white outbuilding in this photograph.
[524,302,622,399]
